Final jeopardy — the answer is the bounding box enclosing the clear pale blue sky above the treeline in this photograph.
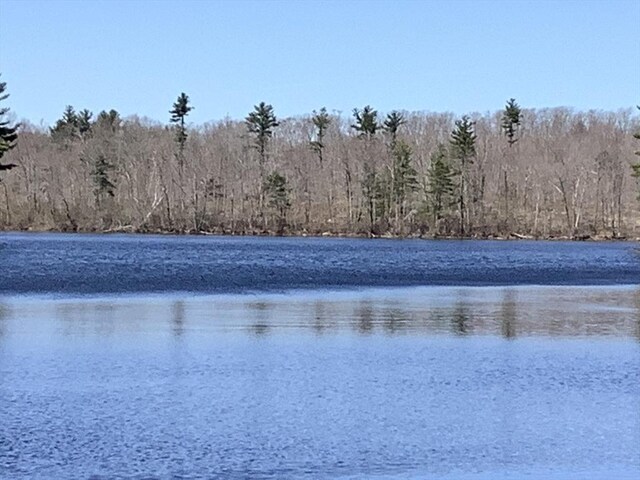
[0,0,640,124]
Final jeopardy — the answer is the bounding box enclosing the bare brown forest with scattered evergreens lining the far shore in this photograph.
[0,83,640,239]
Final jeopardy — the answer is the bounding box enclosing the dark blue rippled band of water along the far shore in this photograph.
[0,234,640,294]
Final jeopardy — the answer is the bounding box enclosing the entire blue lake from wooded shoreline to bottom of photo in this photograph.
[0,234,640,480]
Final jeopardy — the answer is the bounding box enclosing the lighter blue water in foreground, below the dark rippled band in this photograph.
[0,287,640,480]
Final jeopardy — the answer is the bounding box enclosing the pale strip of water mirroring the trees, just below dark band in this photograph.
[0,287,640,339]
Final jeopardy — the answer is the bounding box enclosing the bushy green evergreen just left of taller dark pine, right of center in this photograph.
[427,144,455,233]
